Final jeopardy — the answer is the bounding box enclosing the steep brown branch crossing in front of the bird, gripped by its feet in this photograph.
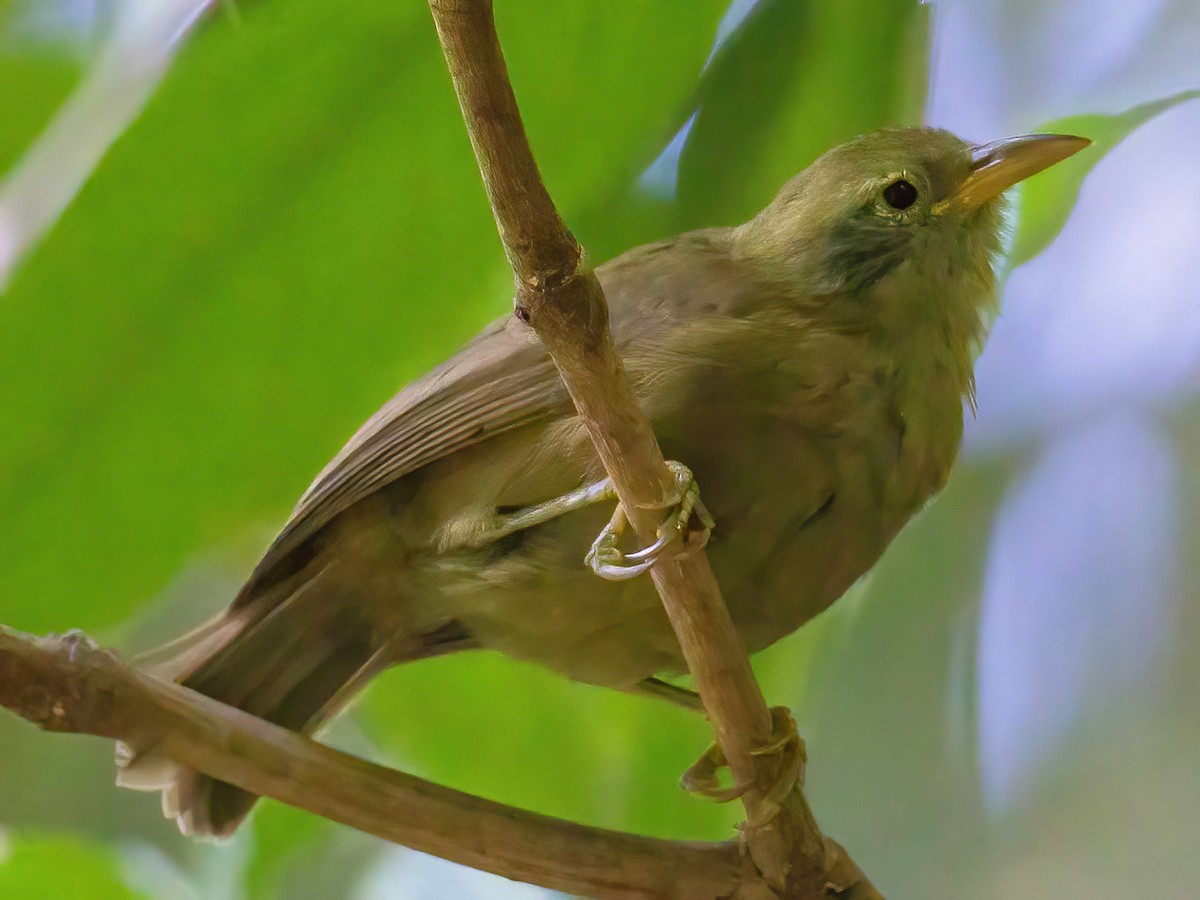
[430,0,878,898]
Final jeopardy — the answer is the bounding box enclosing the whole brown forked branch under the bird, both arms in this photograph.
[0,7,880,900]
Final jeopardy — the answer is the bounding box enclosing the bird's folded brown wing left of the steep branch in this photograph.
[235,318,570,605]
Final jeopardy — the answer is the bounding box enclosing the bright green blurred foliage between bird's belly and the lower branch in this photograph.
[360,653,739,839]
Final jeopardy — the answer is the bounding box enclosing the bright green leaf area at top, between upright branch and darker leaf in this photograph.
[496,0,728,214]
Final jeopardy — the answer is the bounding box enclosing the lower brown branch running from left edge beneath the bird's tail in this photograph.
[0,626,754,898]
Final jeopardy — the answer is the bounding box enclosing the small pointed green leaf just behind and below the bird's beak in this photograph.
[1009,90,1200,269]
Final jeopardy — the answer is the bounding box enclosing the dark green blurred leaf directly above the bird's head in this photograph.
[679,0,930,228]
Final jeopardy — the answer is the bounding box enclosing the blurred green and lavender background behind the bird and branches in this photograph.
[0,0,1200,900]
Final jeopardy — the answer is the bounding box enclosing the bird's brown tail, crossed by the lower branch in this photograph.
[118,570,381,838]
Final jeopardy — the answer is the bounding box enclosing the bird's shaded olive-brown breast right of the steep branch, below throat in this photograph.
[660,334,961,649]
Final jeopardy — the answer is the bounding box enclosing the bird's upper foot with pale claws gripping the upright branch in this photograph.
[584,461,714,581]
